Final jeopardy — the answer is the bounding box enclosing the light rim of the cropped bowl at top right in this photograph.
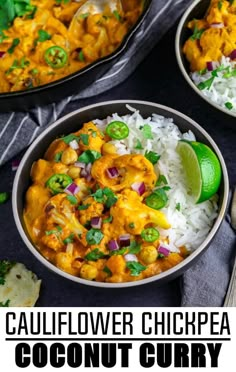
[175,0,236,118]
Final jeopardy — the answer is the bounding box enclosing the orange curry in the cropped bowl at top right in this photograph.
[183,0,236,72]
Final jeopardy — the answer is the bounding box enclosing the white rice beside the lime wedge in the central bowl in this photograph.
[94,106,218,251]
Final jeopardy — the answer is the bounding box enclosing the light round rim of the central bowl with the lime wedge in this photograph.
[12,99,229,288]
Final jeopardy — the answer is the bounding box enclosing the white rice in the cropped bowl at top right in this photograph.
[191,57,236,112]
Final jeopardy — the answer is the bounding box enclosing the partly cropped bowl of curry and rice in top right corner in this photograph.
[175,0,236,117]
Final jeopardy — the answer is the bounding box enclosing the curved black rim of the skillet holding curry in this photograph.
[0,0,153,100]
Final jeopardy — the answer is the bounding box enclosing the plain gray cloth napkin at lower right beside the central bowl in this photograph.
[181,219,236,307]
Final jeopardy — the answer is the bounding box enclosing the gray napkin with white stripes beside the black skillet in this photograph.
[0,0,191,165]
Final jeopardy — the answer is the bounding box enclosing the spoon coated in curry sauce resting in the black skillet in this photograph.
[69,0,122,30]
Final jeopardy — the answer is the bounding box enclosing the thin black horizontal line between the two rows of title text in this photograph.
[5,337,231,342]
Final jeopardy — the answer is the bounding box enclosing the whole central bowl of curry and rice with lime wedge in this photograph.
[12,100,229,288]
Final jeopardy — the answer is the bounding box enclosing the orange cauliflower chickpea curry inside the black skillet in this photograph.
[0,0,143,93]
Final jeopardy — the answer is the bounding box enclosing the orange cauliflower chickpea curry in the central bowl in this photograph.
[24,120,188,283]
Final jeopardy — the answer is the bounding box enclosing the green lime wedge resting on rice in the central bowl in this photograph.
[177,140,222,203]
